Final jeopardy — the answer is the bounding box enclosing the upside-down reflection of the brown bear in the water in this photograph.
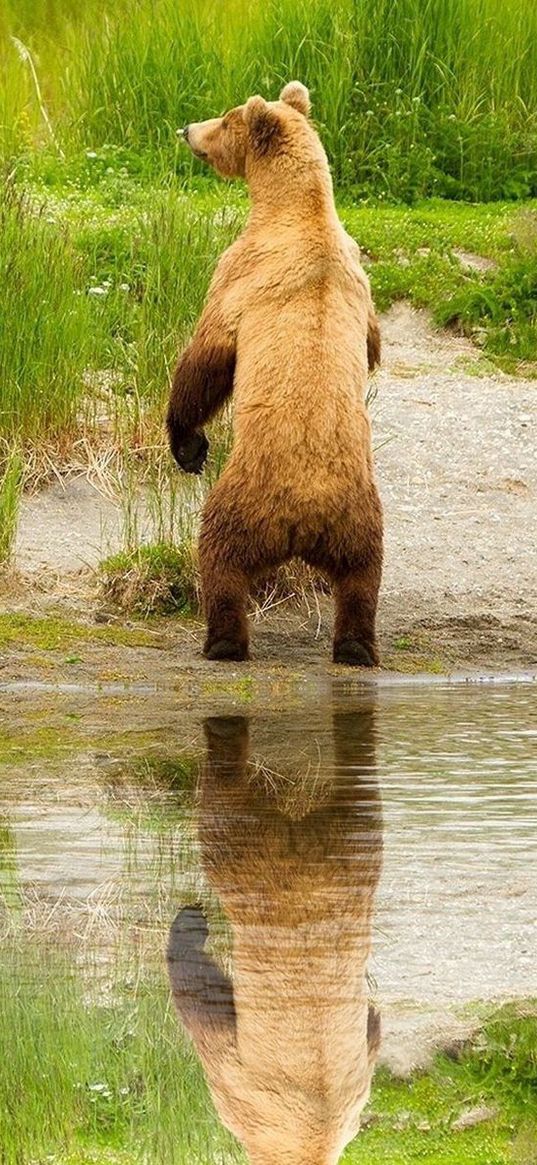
[168,705,382,1165]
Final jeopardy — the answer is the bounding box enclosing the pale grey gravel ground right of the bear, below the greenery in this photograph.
[373,304,537,605]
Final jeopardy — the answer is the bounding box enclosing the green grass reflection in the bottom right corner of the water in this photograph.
[346,1005,537,1165]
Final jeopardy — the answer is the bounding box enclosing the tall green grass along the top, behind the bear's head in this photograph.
[0,0,537,200]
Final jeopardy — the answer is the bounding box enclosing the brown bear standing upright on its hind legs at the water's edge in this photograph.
[168,82,382,666]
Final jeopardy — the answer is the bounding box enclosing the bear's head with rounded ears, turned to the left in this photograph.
[183,80,326,178]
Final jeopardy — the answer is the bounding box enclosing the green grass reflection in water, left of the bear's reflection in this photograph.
[0,942,238,1165]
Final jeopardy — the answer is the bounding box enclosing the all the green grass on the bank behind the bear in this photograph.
[0,0,537,591]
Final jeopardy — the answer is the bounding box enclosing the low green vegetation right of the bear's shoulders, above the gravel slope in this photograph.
[341,200,537,365]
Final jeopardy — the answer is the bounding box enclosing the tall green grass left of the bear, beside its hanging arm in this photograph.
[0,184,238,464]
